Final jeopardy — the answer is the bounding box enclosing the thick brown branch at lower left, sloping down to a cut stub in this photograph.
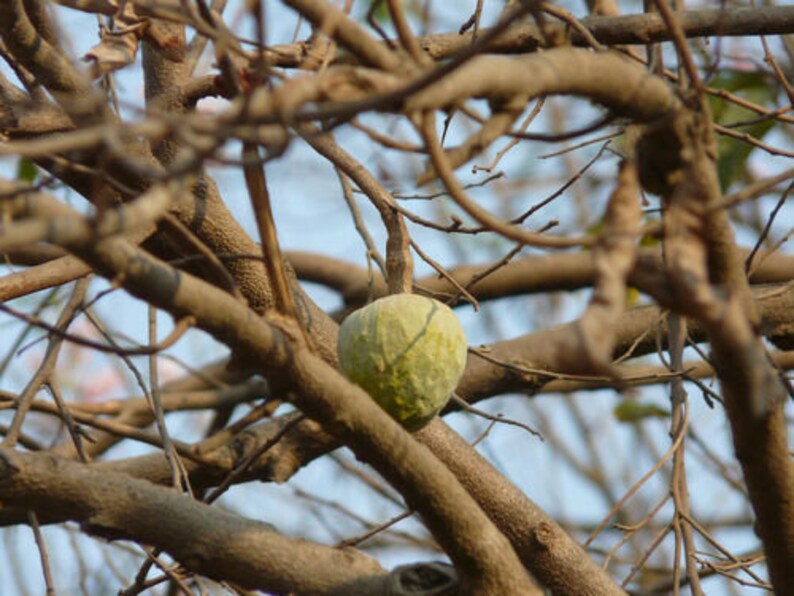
[0,448,385,594]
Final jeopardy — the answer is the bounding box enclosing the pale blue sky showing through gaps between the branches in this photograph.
[0,3,794,595]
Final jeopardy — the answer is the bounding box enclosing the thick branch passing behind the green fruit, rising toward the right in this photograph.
[43,290,794,500]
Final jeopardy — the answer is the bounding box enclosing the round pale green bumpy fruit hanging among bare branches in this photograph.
[337,294,466,430]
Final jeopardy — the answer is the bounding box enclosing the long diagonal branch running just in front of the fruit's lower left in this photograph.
[41,199,530,593]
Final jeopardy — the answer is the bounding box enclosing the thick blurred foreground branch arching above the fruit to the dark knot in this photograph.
[230,47,678,125]
